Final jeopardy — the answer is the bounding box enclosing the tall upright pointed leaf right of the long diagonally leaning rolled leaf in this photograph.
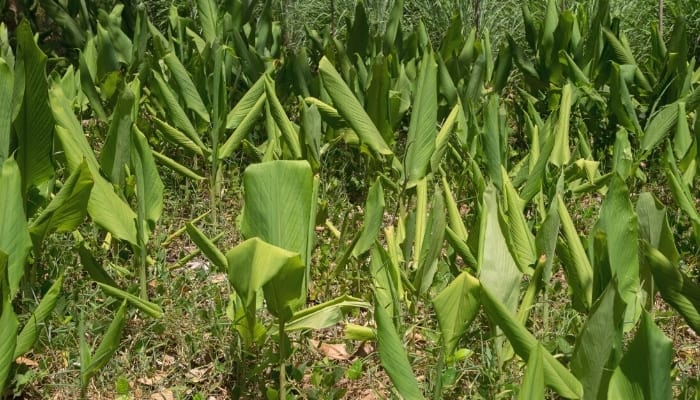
[405,50,437,187]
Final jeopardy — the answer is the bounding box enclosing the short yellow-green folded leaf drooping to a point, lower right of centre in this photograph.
[433,272,481,356]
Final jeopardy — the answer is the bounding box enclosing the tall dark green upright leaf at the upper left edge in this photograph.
[14,21,54,198]
